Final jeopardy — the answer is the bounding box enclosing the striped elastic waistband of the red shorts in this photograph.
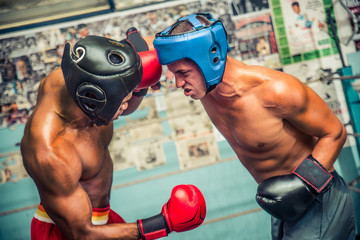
[34,204,110,225]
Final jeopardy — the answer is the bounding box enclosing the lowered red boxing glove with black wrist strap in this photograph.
[137,185,206,240]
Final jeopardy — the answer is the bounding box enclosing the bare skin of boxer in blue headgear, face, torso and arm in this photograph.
[168,57,346,183]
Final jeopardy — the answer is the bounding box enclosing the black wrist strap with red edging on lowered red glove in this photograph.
[137,213,170,240]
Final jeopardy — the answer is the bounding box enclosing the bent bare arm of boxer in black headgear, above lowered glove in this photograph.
[28,140,139,239]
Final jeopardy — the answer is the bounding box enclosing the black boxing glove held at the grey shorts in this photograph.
[256,154,333,221]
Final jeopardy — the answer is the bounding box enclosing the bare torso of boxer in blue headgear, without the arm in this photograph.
[201,60,316,183]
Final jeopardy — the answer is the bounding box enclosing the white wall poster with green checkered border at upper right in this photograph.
[269,0,338,65]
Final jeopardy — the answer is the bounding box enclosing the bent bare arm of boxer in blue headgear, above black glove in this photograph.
[274,74,346,171]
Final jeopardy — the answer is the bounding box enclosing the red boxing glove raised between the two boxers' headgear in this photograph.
[134,50,162,91]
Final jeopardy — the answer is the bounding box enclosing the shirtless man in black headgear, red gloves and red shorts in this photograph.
[21,35,206,240]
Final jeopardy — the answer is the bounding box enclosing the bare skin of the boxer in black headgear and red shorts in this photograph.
[21,68,141,239]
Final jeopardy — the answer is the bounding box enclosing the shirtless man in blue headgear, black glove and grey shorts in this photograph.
[154,13,355,239]
